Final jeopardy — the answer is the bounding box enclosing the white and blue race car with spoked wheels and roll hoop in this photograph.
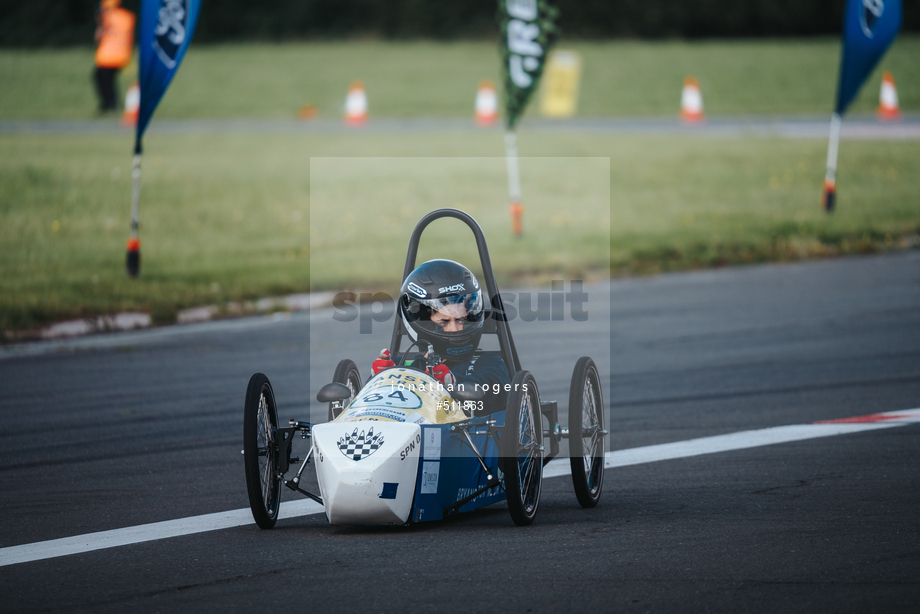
[243,209,607,529]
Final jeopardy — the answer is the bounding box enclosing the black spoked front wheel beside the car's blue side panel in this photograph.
[502,371,543,526]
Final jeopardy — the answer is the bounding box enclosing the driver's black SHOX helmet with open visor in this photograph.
[399,260,484,361]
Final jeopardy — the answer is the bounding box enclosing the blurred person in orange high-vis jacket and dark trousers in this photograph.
[95,0,134,113]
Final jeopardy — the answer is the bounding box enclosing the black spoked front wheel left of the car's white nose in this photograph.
[243,373,281,529]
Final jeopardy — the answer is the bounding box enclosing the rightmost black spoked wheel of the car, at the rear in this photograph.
[569,356,604,507]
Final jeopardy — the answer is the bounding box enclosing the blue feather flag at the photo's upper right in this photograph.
[835,0,902,115]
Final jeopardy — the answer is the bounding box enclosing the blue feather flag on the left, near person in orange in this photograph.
[134,0,201,154]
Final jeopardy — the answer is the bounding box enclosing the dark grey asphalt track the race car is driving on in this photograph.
[0,252,920,612]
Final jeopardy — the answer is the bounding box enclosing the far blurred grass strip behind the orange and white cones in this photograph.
[0,34,920,119]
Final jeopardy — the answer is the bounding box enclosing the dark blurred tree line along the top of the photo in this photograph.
[0,0,920,47]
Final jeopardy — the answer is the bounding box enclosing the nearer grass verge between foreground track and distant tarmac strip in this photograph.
[0,131,920,331]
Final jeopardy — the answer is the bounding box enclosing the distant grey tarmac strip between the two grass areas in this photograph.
[0,114,920,141]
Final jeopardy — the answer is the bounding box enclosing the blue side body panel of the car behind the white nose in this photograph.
[409,412,505,522]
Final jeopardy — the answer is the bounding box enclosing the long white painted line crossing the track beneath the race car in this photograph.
[0,409,920,567]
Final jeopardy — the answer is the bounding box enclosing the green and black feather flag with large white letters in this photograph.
[498,0,559,130]
